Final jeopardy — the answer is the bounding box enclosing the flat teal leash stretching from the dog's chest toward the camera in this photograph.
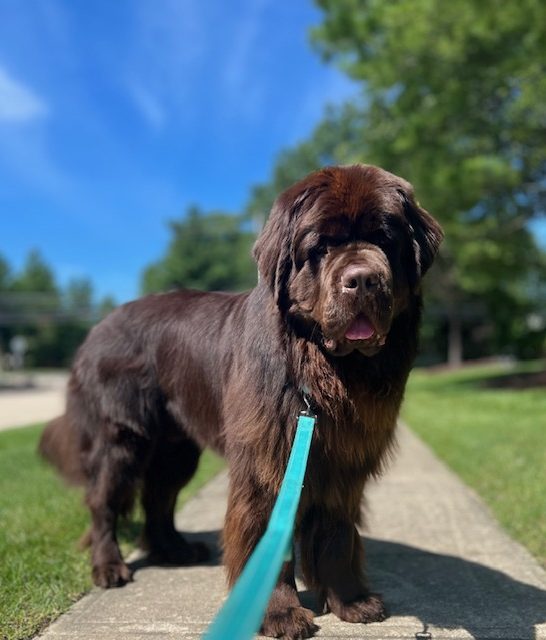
[203,408,316,640]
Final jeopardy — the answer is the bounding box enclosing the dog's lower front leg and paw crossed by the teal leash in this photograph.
[220,478,318,640]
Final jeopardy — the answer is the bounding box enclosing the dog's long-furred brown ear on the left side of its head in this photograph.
[252,183,311,306]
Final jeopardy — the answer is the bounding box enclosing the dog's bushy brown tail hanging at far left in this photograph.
[38,414,86,485]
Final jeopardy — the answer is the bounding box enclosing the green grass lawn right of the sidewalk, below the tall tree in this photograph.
[402,363,546,566]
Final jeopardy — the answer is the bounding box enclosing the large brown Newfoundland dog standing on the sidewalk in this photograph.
[40,165,442,638]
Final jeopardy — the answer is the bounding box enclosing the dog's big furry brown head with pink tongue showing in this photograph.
[254,165,443,356]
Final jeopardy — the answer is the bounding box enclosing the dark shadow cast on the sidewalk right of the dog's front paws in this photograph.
[364,538,546,640]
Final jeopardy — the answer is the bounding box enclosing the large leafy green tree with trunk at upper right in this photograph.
[300,0,546,363]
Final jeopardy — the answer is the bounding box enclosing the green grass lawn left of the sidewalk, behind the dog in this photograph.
[0,426,223,640]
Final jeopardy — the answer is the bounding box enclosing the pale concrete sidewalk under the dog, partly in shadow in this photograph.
[40,429,546,640]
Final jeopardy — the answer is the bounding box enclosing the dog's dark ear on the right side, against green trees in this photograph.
[398,183,444,279]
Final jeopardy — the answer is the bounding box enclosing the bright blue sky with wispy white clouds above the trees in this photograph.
[0,0,357,302]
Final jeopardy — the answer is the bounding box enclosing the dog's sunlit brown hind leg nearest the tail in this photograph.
[86,424,150,588]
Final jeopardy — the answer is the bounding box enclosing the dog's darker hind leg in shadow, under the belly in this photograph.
[142,436,210,565]
